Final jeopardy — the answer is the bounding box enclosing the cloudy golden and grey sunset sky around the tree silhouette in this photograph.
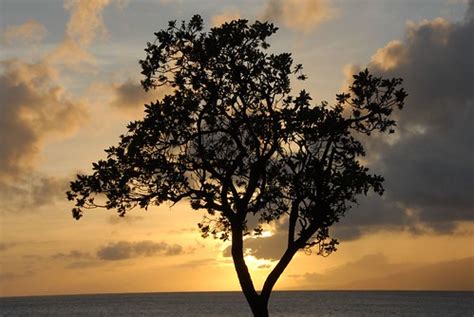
[0,0,474,296]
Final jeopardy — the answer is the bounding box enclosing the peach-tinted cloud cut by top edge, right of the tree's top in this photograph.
[262,0,335,32]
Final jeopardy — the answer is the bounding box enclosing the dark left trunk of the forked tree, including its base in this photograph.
[232,223,268,317]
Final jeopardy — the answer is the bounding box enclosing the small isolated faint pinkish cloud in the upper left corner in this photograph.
[2,20,46,45]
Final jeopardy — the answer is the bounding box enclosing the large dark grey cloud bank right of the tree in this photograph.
[336,2,474,239]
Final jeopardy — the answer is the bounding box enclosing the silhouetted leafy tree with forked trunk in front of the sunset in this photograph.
[67,15,407,316]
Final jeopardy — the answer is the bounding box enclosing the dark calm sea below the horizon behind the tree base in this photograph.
[0,291,474,317]
